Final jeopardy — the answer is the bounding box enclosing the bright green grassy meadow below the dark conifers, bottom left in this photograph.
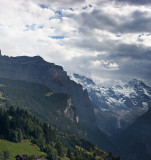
[0,139,46,160]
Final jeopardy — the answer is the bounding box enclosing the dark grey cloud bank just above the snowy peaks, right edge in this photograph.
[92,44,151,85]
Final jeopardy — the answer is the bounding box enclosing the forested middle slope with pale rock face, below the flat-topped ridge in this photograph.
[0,78,81,137]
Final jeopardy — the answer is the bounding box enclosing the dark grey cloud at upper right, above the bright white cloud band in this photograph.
[74,9,151,33]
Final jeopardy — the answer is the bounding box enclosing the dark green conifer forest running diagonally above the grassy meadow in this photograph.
[0,107,119,160]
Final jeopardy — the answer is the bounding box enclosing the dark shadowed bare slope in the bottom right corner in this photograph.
[112,110,151,160]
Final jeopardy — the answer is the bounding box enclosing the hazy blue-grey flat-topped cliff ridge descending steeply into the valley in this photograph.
[0,56,114,151]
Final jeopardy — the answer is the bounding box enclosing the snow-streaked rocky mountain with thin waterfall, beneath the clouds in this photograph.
[72,74,151,135]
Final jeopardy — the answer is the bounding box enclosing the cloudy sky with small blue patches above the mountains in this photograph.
[0,0,151,86]
